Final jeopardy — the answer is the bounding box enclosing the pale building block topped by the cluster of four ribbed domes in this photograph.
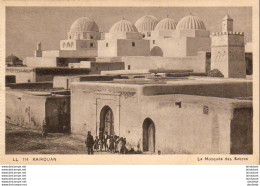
[96,15,211,73]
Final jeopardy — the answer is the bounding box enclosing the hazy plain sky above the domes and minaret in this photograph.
[6,7,252,59]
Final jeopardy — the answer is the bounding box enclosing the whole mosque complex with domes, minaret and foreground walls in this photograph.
[6,14,253,154]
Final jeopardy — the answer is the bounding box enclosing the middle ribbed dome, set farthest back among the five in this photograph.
[135,15,159,32]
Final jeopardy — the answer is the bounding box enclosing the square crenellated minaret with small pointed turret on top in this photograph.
[211,14,246,78]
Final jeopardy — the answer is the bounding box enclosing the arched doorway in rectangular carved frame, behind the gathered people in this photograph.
[99,106,114,138]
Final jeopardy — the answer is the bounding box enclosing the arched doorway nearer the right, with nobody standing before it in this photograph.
[143,118,155,152]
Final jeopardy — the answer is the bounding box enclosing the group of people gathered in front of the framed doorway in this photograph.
[85,131,127,154]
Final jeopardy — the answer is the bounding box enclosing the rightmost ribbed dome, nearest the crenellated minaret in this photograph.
[176,15,206,30]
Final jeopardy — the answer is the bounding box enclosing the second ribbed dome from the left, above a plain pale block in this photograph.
[109,19,138,33]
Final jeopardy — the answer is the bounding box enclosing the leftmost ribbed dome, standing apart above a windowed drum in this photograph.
[70,17,99,32]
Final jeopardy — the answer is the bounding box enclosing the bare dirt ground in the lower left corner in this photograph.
[5,124,94,154]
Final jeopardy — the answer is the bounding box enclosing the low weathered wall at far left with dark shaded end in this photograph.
[6,90,70,132]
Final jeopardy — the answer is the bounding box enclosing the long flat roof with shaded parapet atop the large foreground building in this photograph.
[71,77,252,99]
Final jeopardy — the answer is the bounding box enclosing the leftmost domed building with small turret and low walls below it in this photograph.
[6,17,123,83]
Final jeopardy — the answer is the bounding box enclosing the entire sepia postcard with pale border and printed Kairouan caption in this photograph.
[0,0,259,165]
